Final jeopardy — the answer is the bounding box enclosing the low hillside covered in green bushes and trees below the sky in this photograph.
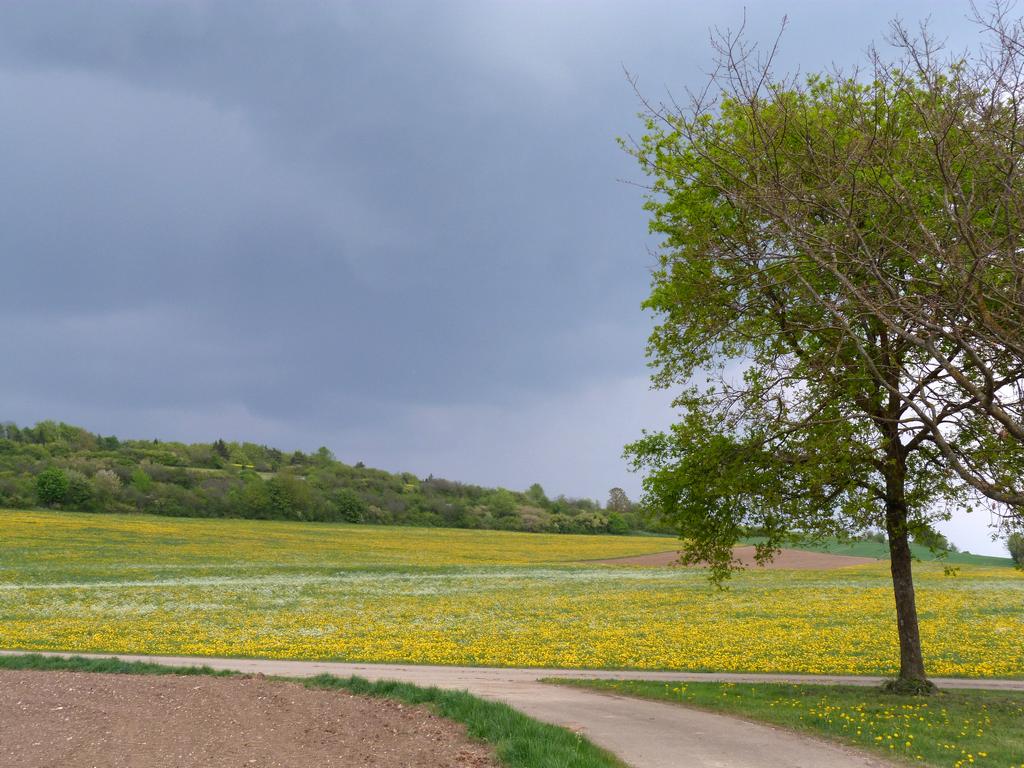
[0,421,639,534]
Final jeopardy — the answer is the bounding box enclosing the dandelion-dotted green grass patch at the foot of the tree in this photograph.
[546,678,1024,768]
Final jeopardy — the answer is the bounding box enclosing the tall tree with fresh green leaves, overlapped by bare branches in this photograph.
[628,8,1024,689]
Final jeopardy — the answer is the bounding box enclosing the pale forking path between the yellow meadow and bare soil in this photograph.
[25,651,1024,768]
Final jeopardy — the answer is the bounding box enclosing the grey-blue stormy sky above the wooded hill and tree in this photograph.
[0,0,1000,553]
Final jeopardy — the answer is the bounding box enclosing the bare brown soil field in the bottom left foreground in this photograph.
[0,670,497,768]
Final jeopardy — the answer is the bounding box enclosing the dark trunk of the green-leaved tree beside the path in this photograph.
[886,456,929,688]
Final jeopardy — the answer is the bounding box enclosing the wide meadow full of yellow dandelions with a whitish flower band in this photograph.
[0,511,1024,677]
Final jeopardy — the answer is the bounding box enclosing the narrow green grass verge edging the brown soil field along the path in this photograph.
[0,653,626,768]
